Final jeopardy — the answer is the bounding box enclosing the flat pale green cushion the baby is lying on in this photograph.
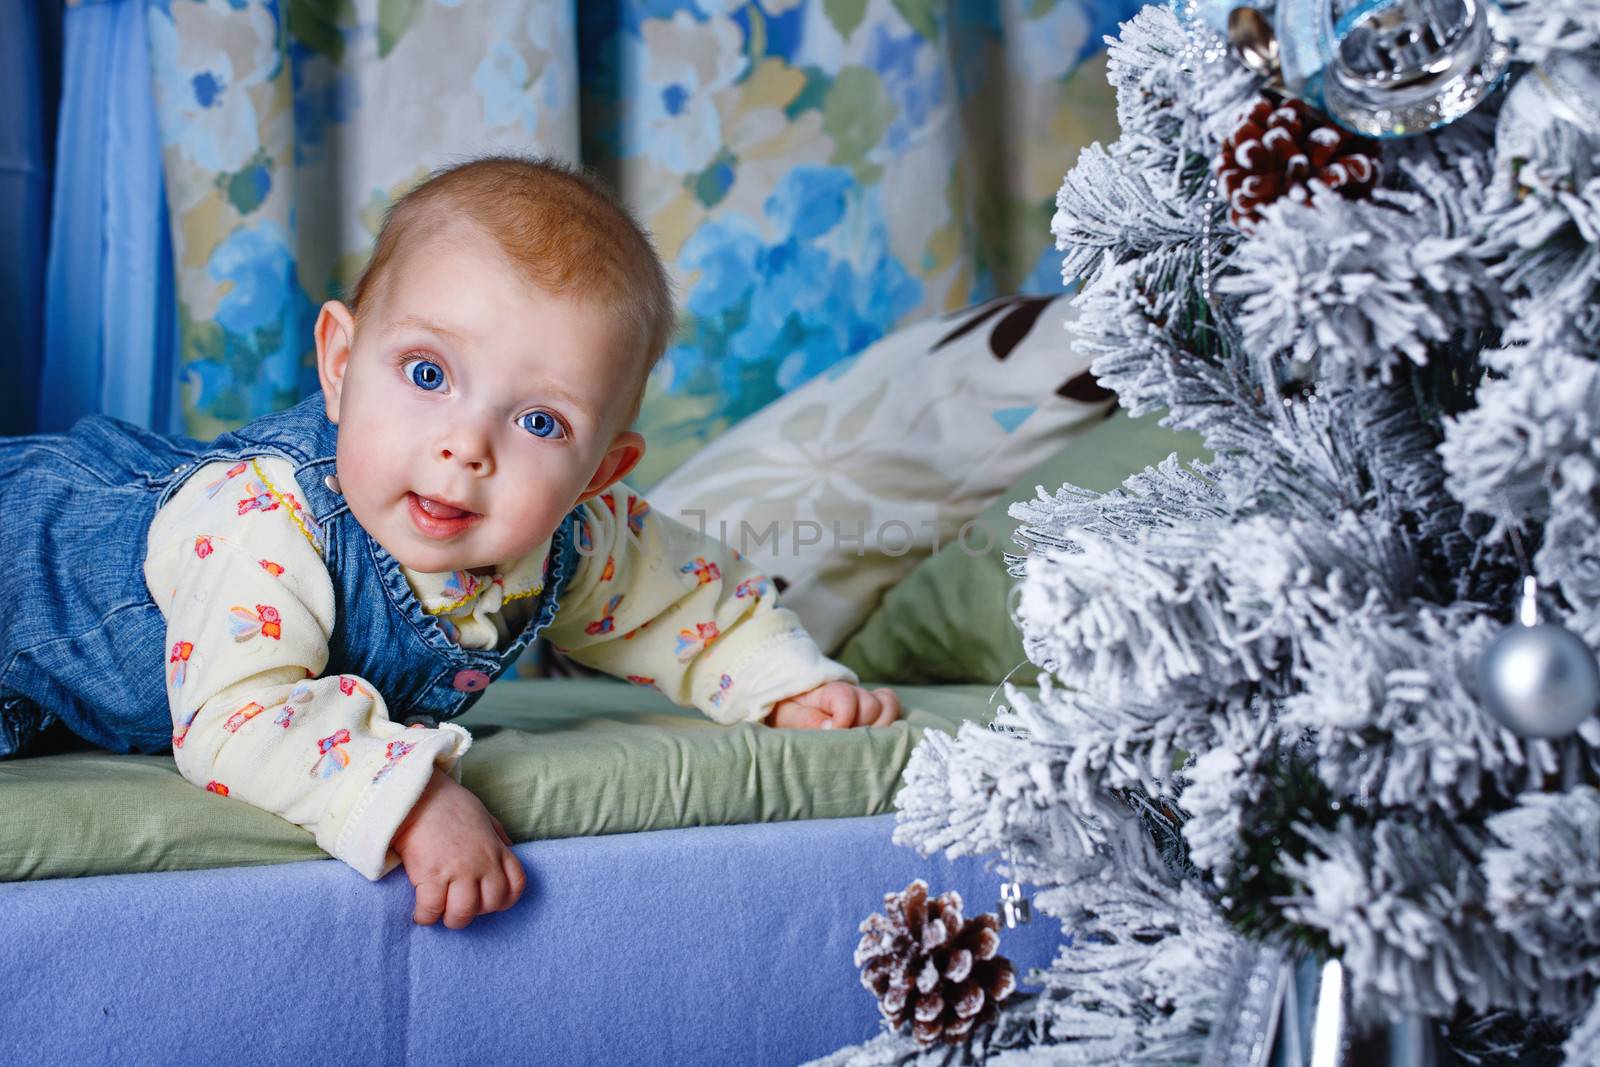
[0,678,1017,881]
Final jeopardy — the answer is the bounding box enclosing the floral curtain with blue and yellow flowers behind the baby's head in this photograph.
[147,0,1136,486]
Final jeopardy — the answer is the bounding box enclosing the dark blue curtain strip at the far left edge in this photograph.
[0,0,61,434]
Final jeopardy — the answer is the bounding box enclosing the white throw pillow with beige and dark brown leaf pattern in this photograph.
[650,296,1112,653]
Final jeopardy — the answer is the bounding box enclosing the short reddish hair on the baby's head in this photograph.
[349,155,677,414]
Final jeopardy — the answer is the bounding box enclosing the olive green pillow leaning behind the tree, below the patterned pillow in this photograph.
[834,410,1206,685]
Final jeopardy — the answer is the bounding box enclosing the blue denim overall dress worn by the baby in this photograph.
[0,395,579,758]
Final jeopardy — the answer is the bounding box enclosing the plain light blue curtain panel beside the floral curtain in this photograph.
[37,0,179,430]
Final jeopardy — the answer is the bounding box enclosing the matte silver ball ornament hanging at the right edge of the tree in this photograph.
[1478,577,1600,737]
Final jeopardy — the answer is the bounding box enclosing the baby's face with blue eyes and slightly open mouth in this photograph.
[317,217,643,573]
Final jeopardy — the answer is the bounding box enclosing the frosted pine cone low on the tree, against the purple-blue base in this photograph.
[856,878,1016,1045]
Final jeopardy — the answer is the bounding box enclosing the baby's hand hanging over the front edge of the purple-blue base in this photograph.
[389,766,528,929]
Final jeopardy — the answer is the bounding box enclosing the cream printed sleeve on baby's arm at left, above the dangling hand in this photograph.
[146,459,470,880]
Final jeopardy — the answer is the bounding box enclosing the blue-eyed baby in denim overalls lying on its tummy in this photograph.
[0,158,899,928]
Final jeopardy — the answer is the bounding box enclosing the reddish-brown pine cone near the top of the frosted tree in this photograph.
[1216,98,1379,229]
